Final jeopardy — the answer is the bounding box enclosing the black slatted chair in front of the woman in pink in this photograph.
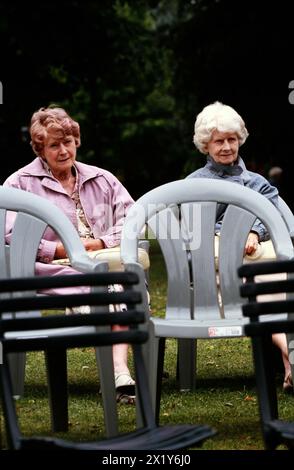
[0,272,215,450]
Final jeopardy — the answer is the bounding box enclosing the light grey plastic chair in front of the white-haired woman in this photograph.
[121,179,293,416]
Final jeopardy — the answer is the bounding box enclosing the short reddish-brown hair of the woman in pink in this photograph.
[30,107,81,157]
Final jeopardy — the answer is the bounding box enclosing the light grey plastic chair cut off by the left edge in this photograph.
[0,186,118,436]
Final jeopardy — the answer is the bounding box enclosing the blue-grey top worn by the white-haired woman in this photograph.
[187,156,279,241]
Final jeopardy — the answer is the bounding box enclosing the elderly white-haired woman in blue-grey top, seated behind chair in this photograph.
[188,101,293,390]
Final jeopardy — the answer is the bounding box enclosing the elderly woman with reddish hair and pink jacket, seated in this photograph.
[4,107,135,402]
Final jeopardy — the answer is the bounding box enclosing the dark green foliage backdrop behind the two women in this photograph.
[0,0,294,205]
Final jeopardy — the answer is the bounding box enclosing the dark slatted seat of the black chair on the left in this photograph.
[21,424,215,450]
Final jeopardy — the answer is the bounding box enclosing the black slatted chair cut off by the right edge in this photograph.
[238,260,294,450]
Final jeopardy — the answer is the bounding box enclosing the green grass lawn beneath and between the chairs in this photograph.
[1,244,294,450]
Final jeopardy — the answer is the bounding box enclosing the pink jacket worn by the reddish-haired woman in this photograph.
[3,157,134,266]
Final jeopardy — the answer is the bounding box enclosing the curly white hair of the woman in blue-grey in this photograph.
[193,101,249,154]
